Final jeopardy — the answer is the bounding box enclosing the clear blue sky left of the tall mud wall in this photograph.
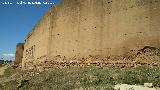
[0,0,62,59]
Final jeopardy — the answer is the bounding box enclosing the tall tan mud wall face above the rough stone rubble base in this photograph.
[23,0,160,67]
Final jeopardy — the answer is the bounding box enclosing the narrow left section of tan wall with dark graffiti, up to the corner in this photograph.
[22,14,50,68]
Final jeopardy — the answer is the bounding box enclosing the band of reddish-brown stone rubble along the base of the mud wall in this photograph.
[22,46,160,71]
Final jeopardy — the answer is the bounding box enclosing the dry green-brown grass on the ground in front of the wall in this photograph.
[0,66,160,90]
